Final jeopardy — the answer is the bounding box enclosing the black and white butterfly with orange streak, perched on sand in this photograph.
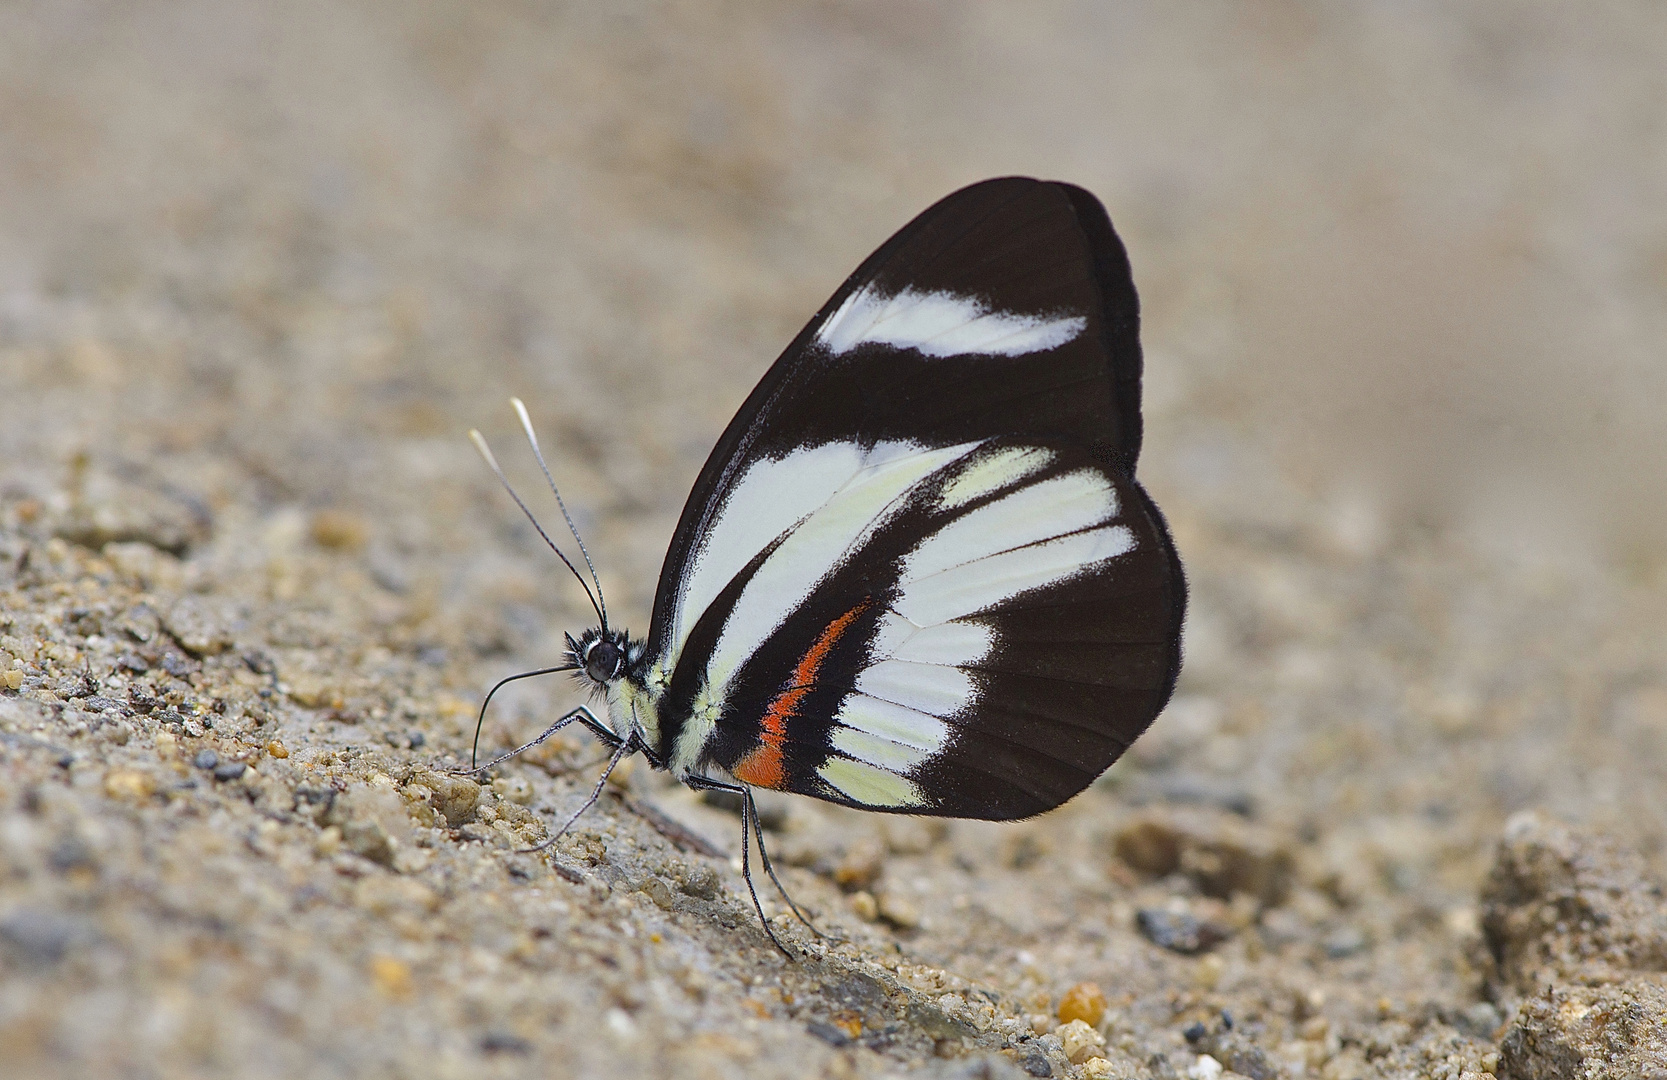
[475,177,1185,940]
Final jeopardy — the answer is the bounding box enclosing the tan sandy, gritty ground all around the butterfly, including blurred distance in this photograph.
[0,3,1667,1080]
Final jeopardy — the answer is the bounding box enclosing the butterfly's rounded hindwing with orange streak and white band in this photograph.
[696,443,1174,818]
